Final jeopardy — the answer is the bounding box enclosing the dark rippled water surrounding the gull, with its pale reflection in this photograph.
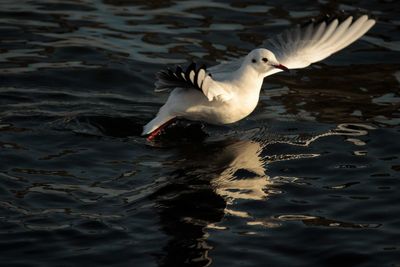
[0,0,400,266]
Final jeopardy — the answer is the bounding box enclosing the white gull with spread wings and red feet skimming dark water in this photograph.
[142,15,376,141]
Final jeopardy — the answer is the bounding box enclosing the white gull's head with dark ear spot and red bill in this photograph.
[246,48,289,73]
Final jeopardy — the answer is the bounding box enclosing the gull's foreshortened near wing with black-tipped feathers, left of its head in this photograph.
[155,63,231,101]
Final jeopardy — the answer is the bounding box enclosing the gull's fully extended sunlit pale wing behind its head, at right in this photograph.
[263,15,375,76]
